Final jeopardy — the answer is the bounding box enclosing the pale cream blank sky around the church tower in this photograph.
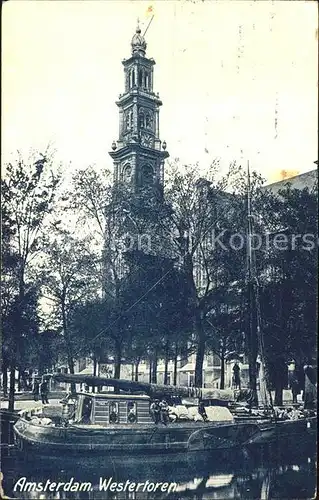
[2,0,318,182]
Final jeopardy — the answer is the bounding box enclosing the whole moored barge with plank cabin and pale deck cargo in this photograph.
[14,376,316,455]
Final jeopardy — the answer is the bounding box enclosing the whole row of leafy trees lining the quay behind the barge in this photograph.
[2,153,317,408]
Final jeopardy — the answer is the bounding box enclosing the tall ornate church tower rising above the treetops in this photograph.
[109,26,169,192]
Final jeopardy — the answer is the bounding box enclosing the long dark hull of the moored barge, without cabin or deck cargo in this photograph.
[14,418,316,455]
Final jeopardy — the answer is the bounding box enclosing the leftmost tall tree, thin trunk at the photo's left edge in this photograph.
[1,152,60,411]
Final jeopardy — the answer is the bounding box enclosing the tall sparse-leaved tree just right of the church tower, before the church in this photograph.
[160,166,225,386]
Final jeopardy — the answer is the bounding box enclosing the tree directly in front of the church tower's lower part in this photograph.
[68,168,174,378]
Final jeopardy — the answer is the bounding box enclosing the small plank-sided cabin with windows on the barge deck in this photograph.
[75,393,152,425]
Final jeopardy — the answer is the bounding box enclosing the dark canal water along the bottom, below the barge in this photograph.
[1,444,317,500]
